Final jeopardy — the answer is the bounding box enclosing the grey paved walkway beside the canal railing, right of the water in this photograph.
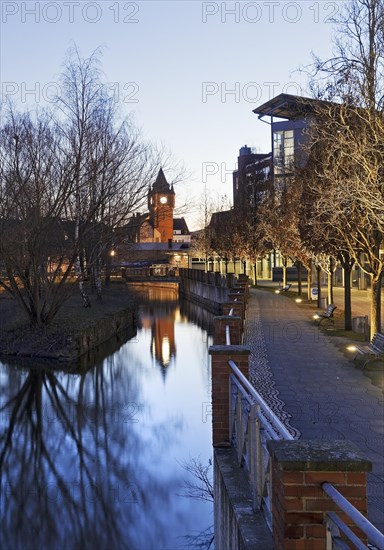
[245,289,384,531]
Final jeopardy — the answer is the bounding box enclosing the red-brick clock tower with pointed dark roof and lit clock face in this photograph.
[148,168,175,243]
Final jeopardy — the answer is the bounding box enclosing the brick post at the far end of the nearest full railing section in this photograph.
[209,345,250,447]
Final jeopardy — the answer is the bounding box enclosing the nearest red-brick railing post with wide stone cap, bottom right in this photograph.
[267,439,372,550]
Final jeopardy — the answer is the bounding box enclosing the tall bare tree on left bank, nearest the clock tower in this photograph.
[57,48,159,306]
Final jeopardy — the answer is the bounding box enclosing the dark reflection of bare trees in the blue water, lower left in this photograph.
[0,358,177,549]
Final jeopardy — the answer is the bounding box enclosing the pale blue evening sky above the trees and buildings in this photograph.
[0,0,340,228]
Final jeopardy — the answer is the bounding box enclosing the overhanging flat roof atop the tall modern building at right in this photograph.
[253,94,329,119]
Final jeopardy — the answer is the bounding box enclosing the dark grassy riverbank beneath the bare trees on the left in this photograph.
[0,281,136,363]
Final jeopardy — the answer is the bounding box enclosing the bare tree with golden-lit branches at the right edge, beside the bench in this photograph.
[304,0,384,335]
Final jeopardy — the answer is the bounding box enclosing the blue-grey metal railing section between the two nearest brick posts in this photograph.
[228,360,294,530]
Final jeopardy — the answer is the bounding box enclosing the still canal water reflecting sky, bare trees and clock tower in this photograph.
[0,288,213,550]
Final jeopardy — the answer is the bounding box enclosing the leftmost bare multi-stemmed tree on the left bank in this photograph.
[0,109,76,325]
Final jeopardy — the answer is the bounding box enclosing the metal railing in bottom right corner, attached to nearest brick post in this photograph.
[321,482,384,550]
